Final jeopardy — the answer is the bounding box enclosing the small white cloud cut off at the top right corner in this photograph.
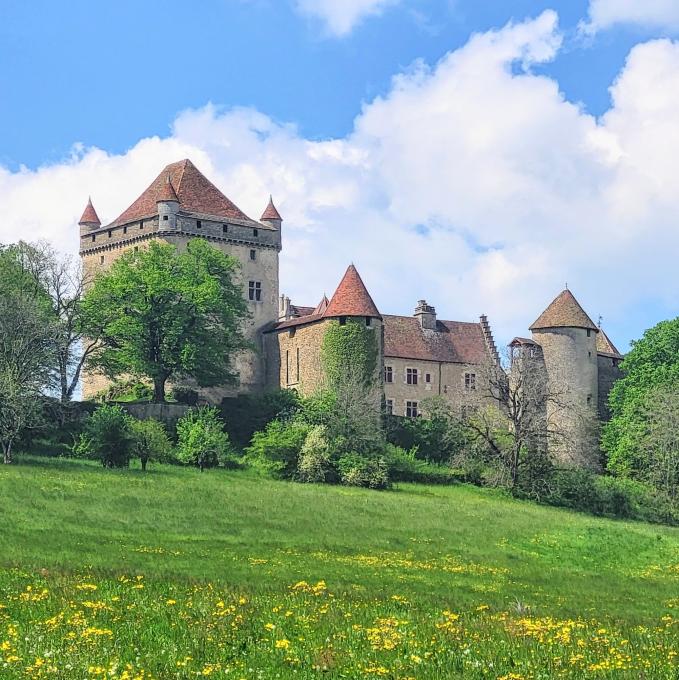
[585,0,679,32]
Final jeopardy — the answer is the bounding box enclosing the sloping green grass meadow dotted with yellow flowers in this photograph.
[0,457,679,680]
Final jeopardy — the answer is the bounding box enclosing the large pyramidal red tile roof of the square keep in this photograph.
[112,159,253,225]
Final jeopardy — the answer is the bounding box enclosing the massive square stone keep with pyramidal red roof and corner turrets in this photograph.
[79,159,283,402]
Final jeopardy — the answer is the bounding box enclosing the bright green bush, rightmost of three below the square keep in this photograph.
[177,407,236,472]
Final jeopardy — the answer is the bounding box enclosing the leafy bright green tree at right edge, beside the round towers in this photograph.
[602,317,679,477]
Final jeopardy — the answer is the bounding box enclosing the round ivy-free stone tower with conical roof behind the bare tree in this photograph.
[530,289,599,467]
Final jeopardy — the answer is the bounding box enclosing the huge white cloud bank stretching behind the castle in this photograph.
[0,12,679,345]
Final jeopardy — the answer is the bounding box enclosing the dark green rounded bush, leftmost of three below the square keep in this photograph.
[73,404,134,468]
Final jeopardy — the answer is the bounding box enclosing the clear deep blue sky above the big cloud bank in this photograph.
[0,0,660,168]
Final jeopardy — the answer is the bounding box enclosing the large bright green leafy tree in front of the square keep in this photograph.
[83,239,248,402]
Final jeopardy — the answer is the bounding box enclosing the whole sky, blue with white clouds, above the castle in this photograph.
[0,0,679,351]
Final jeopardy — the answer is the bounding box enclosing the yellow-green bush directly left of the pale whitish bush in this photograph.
[246,420,311,479]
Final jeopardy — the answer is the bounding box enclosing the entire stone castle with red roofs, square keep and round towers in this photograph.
[79,159,622,468]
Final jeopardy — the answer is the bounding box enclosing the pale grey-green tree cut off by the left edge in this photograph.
[0,280,55,463]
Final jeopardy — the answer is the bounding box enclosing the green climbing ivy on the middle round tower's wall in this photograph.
[321,318,378,384]
